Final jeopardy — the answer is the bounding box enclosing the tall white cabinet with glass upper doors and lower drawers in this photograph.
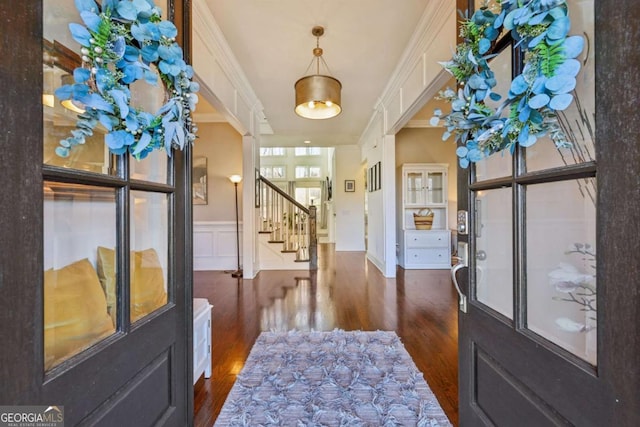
[397,163,451,269]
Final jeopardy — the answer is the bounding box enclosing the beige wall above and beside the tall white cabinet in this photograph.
[396,128,458,228]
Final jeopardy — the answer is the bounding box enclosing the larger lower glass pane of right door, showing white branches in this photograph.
[526,178,597,364]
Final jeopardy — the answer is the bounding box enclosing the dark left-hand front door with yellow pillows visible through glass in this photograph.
[0,0,193,427]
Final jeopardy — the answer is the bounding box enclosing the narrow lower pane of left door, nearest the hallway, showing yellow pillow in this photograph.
[130,191,169,323]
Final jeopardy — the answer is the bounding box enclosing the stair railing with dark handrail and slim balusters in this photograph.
[259,175,318,270]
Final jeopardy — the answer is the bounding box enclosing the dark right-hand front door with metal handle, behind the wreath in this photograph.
[452,0,640,426]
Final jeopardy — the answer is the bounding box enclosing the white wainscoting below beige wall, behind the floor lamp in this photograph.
[193,221,242,271]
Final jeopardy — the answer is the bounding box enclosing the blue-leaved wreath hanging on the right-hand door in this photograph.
[431,0,584,168]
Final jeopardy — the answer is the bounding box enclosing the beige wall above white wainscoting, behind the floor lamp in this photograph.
[193,123,242,221]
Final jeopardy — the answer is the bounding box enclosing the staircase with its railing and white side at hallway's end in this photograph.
[258,175,318,270]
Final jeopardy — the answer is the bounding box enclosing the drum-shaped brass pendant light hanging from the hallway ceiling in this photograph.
[295,26,342,120]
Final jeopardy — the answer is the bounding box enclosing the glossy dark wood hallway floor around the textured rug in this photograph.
[194,244,458,427]
